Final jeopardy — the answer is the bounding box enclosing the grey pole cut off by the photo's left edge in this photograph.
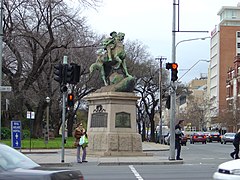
[0,0,3,140]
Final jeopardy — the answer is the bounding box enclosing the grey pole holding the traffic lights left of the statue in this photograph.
[61,56,67,163]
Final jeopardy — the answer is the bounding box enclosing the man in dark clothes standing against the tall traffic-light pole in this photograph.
[175,120,184,160]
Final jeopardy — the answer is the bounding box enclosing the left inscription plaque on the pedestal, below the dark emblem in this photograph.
[91,112,108,128]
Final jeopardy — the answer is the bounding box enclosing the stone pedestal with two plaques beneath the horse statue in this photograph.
[85,92,144,156]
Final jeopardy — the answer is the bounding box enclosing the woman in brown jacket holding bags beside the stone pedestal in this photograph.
[74,123,87,163]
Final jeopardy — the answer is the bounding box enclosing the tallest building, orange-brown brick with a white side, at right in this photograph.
[208,3,240,122]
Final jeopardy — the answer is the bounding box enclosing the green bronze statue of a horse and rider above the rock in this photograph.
[90,31,132,86]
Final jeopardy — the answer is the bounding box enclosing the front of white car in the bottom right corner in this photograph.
[213,159,240,180]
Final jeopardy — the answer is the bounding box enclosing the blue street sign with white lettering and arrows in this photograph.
[11,121,21,148]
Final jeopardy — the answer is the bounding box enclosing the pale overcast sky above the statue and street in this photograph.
[77,0,240,83]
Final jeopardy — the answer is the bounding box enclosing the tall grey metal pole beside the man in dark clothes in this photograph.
[169,0,176,160]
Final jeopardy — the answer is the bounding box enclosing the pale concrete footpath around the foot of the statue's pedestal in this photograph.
[21,142,183,166]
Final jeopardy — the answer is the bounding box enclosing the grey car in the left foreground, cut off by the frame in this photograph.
[0,143,84,180]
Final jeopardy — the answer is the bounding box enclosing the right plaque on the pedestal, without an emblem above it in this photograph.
[115,112,131,128]
